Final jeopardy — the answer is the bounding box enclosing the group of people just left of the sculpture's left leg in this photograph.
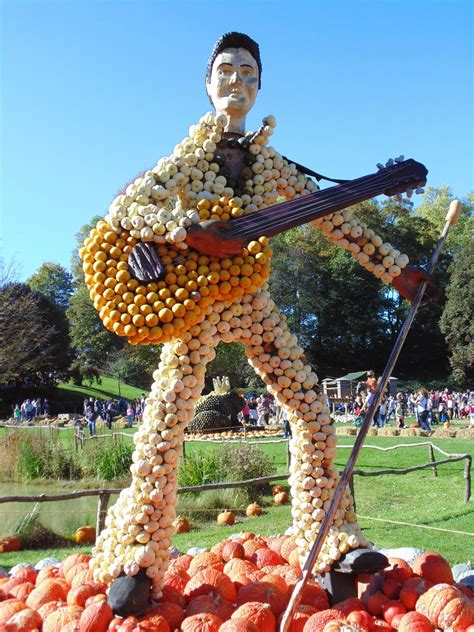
[82,393,146,437]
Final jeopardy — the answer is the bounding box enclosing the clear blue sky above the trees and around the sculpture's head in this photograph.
[0,0,474,279]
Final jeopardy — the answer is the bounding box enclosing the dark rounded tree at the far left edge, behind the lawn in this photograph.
[0,283,72,385]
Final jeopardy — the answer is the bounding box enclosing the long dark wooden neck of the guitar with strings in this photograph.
[230,160,427,240]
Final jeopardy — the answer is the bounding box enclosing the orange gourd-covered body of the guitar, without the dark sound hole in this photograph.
[80,198,272,344]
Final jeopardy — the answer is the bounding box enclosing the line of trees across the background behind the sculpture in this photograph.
[0,187,474,404]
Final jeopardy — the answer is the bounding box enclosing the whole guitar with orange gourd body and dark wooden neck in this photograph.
[80,159,428,344]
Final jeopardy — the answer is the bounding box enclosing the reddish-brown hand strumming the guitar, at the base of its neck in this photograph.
[186,220,247,259]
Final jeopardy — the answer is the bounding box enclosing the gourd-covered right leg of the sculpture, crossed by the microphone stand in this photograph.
[243,288,366,572]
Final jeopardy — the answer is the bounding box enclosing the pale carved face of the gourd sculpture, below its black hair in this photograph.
[206,48,258,118]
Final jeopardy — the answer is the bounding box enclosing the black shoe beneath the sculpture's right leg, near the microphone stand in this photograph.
[319,549,389,604]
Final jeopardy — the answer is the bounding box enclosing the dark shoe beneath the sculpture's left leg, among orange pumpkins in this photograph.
[107,568,152,617]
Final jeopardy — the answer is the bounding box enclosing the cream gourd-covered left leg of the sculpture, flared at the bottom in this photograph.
[92,321,217,593]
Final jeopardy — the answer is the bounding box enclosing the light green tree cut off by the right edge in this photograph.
[440,243,474,386]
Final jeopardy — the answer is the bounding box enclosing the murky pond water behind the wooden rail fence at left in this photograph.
[0,481,124,537]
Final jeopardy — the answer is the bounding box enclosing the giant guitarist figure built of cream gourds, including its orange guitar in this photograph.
[80,33,426,595]
